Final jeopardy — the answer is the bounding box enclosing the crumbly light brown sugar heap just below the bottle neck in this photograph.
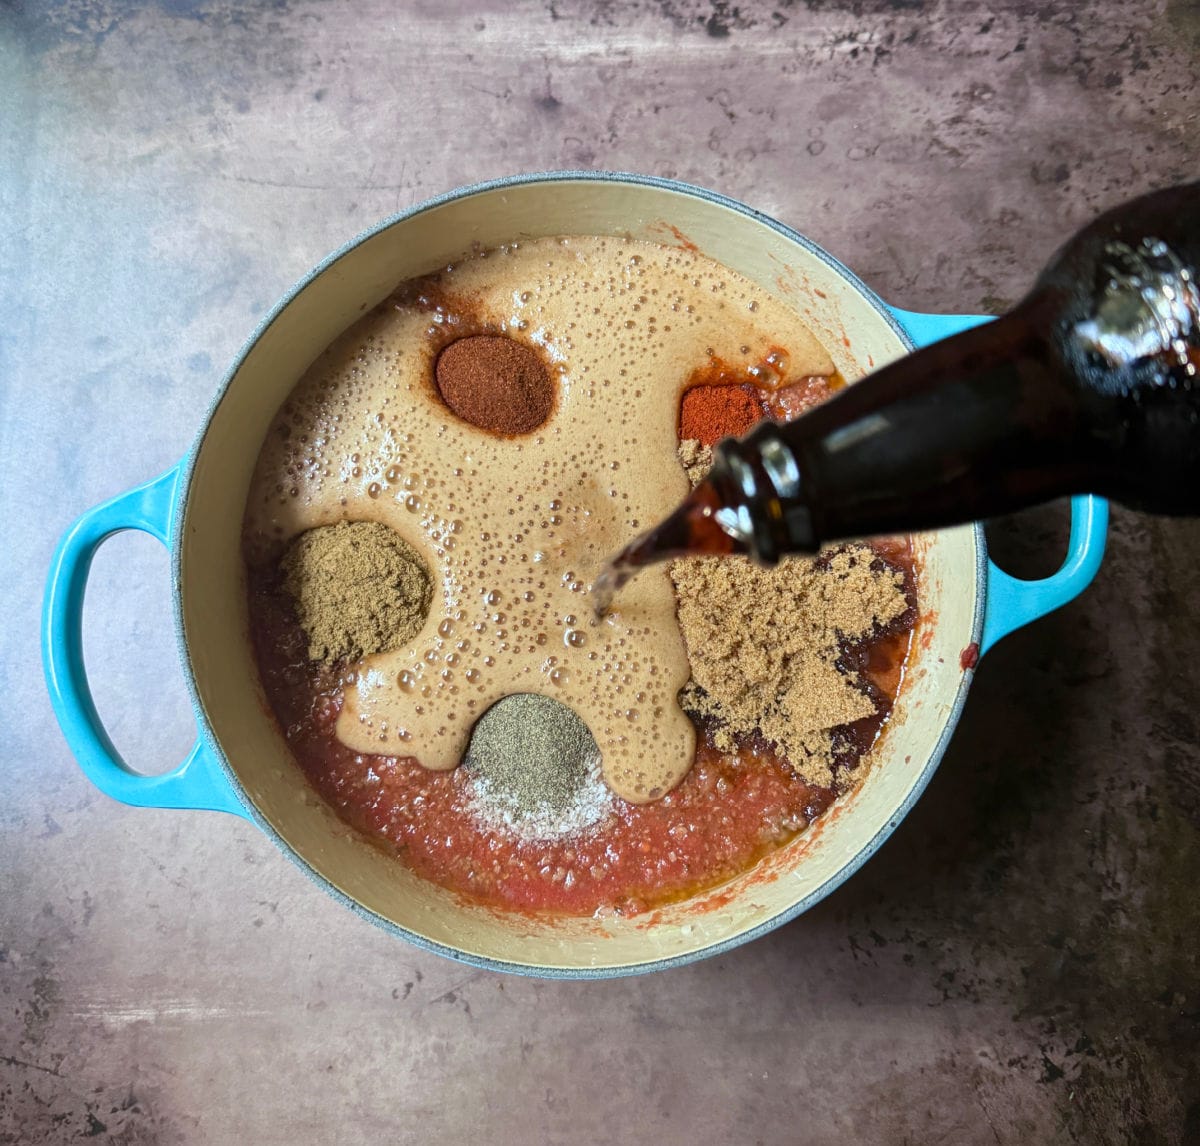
[671,440,907,787]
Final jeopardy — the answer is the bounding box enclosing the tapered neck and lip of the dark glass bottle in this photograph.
[710,292,1102,563]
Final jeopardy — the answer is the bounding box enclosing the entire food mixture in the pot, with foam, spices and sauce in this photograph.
[244,236,917,914]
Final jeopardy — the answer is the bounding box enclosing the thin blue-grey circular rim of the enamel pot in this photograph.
[170,170,988,979]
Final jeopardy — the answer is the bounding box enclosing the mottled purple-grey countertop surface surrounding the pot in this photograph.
[0,0,1200,1146]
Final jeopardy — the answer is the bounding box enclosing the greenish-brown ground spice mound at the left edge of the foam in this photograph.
[280,521,433,664]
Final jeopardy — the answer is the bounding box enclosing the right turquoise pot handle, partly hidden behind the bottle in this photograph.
[888,306,1109,667]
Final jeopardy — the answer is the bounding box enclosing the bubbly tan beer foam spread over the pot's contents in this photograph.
[246,236,833,803]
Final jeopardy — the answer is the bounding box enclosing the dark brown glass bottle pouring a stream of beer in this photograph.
[598,184,1200,604]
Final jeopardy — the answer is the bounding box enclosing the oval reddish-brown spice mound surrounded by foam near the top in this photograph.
[434,335,554,434]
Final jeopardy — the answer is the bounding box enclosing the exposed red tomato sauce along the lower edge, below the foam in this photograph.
[243,388,917,916]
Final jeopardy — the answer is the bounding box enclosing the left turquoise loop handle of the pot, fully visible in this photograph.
[42,463,247,816]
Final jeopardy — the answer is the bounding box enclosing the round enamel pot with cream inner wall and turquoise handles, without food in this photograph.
[43,173,1106,978]
